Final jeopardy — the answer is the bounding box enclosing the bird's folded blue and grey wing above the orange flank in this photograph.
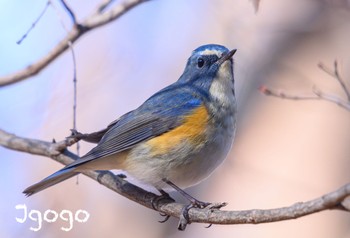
[64,86,202,169]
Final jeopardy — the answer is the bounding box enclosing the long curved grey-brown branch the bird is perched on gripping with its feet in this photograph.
[0,130,350,229]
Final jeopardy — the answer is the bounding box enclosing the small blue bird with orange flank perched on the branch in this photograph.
[23,44,236,218]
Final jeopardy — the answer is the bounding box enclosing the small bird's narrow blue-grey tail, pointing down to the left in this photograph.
[23,167,79,197]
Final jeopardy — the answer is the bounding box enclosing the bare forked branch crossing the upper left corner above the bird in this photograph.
[0,0,148,87]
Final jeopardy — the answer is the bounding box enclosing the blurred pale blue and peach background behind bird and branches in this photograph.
[0,0,350,238]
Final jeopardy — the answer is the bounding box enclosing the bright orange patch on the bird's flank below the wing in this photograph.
[147,105,209,155]
